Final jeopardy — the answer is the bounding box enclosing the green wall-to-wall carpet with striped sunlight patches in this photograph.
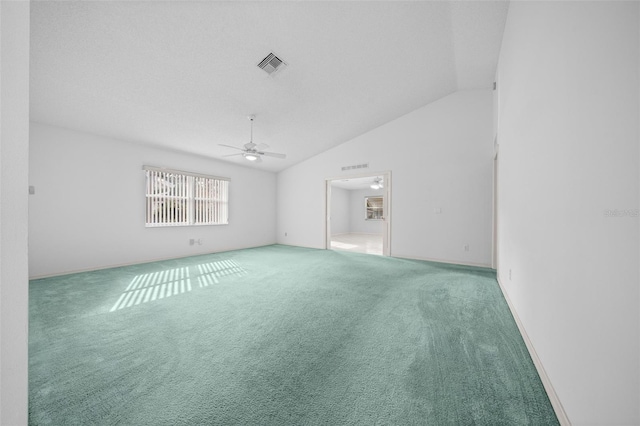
[29,245,558,425]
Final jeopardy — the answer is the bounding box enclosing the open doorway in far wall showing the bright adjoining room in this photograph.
[325,172,391,256]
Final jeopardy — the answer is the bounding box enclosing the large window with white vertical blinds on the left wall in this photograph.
[143,166,229,227]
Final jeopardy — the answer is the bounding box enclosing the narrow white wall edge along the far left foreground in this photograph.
[0,1,30,425]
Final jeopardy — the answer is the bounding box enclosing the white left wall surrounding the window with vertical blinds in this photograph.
[29,123,276,277]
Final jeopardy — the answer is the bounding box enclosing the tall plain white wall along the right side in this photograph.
[498,2,640,425]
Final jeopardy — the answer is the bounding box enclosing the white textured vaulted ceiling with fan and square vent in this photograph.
[31,1,508,171]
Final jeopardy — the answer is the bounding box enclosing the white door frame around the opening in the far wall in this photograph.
[324,170,392,256]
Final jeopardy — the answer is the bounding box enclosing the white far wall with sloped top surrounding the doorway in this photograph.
[277,90,493,265]
